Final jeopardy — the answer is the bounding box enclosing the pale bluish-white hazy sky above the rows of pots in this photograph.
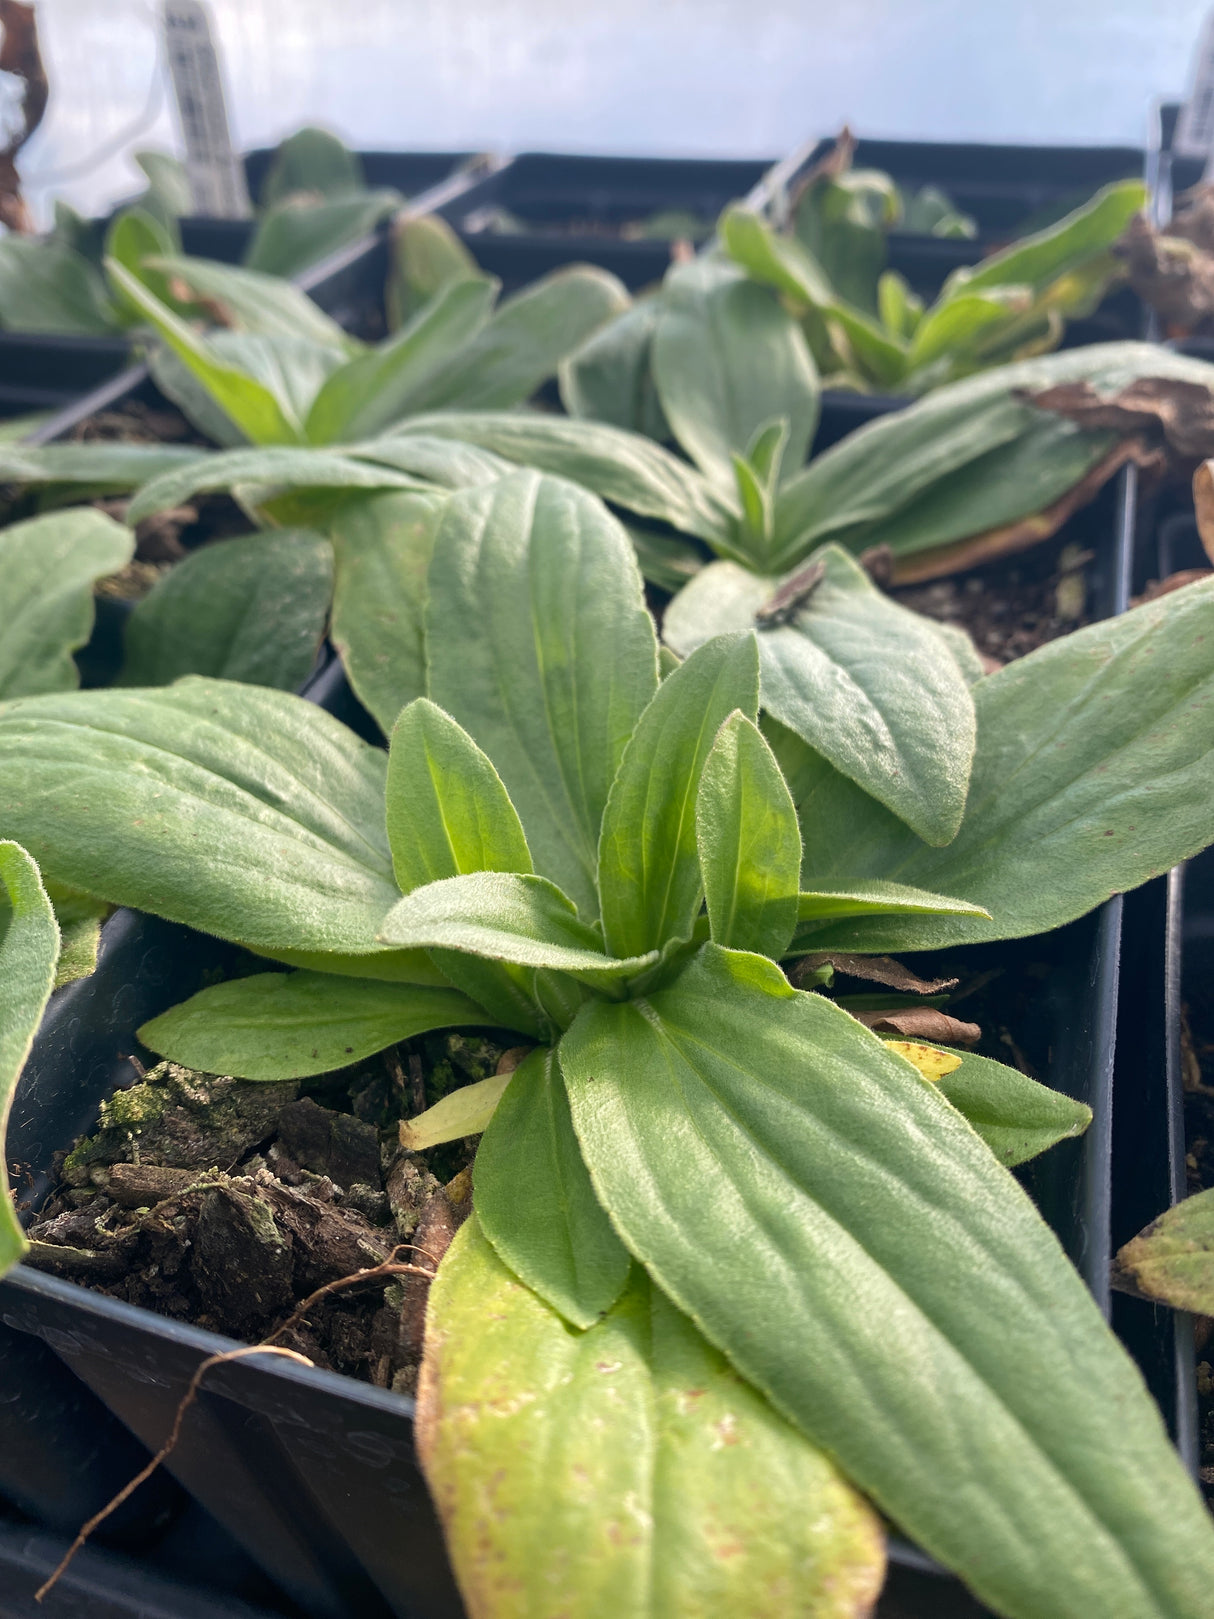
[9,0,1208,225]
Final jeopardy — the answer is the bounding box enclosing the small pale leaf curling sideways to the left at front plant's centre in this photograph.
[380,871,657,989]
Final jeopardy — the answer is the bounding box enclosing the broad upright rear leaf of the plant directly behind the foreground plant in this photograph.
[652,259,819,487]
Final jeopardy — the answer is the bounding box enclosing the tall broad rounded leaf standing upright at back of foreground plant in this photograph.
[426,473,657,926]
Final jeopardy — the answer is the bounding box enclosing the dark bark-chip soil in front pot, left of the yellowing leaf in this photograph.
[28,1033,515,1394]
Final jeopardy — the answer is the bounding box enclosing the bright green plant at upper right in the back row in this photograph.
[719,175,1146,395]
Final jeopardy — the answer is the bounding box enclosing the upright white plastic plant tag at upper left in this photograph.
[163,0,253,219]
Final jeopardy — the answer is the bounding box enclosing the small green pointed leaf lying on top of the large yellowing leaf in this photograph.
[473,1049,633,1328]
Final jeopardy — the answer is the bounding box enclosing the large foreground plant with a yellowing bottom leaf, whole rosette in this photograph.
[0,473,1214,1619]
